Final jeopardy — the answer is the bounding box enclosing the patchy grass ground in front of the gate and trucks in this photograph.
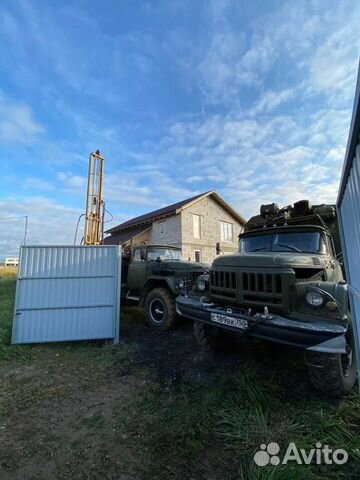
[0,278,360,480]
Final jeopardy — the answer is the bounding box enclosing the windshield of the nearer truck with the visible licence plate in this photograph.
[239,231,326,253]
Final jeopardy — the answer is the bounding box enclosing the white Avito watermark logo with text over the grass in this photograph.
[254,442,349,467]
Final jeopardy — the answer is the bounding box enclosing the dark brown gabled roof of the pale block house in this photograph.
[106,190,246,233]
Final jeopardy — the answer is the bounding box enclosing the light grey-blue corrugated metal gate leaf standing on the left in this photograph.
[12,245,121,343]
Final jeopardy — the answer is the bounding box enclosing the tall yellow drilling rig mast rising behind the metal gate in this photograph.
[84,150,105,245]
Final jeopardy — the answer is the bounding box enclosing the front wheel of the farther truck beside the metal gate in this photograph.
[145,288,176,330]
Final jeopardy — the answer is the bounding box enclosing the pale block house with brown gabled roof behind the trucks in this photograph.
[105,191,245,263]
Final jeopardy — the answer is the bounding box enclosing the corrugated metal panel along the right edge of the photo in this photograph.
[337,62,360,374]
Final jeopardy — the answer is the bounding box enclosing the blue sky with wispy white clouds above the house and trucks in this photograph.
[0,0,360,261]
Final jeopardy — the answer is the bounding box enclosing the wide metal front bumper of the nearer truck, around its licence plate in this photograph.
[176,296,347,353]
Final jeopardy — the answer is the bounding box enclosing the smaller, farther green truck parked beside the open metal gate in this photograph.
[121,245,208,330]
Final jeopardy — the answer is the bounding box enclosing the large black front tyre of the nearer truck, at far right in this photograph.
[306,332,356,397]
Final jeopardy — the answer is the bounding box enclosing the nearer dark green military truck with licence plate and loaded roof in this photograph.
[176,200,356,396]
